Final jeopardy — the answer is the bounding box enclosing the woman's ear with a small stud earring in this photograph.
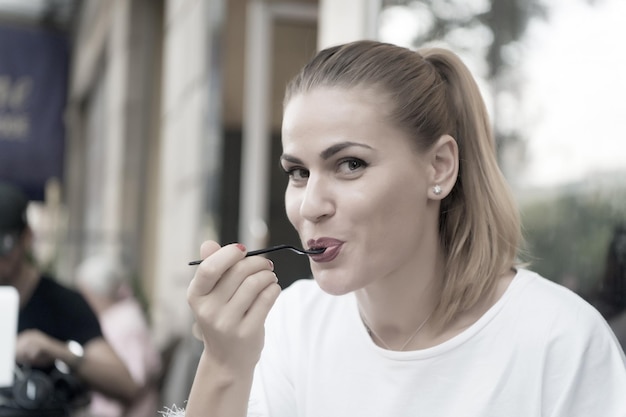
[428,135,459,200]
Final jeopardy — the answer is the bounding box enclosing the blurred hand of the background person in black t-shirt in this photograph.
[15,329,63,367]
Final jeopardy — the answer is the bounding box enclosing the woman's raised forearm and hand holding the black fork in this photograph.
[180,242,280,417]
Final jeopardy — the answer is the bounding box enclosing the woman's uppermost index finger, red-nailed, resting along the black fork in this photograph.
[187,242,246,302]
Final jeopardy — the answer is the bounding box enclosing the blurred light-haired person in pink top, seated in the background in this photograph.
[76,254,161,417]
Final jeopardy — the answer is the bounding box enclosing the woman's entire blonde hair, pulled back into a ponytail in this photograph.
[284,41,522,325]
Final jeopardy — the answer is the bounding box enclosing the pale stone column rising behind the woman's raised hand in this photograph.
[153,0,224,345]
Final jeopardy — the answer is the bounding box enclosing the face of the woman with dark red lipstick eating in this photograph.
[281,88,438,294]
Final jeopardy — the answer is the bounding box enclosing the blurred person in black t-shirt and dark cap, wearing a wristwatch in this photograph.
[0,182,138,412]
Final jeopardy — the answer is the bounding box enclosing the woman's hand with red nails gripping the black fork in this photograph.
[187,241,280,372]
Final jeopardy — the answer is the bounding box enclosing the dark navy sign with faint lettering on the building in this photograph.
[0,26,69,200]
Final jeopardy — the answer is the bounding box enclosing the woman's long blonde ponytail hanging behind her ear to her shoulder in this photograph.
[419,48,521,322]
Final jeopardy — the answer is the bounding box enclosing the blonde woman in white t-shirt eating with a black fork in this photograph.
[176,41,626,417]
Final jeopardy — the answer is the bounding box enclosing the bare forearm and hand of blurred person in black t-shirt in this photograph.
[16,330,139,402]
